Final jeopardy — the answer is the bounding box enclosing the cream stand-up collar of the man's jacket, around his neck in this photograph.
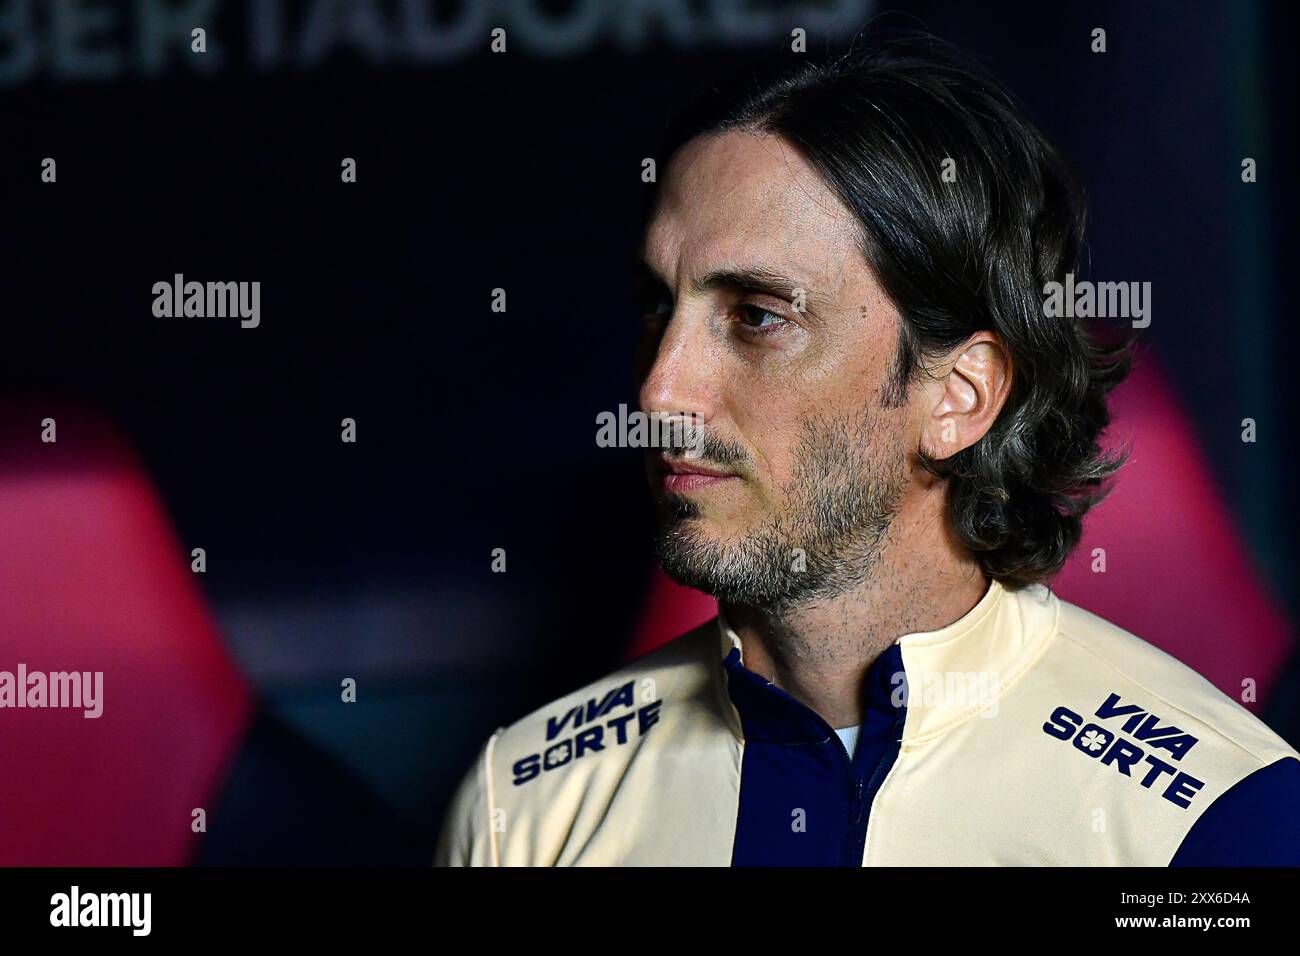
[716,580,1060,749]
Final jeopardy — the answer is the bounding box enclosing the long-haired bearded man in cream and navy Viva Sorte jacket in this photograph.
[437,42,1300,866]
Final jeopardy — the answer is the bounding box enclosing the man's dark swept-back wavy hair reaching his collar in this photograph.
[646,34,1132,588]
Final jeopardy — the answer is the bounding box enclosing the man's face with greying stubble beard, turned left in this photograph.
[638,131,917,606]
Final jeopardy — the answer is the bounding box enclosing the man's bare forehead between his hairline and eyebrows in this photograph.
[644,130,859,287]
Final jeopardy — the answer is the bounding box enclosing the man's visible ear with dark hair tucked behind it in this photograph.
[920,332,1013,459]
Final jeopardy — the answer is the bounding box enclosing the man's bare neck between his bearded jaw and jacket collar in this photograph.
[723,502,988,727]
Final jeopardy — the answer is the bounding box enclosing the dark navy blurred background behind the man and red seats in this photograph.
[0,0,1300,862]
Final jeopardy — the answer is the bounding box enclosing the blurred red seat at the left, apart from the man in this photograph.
[0,399,252,866]
